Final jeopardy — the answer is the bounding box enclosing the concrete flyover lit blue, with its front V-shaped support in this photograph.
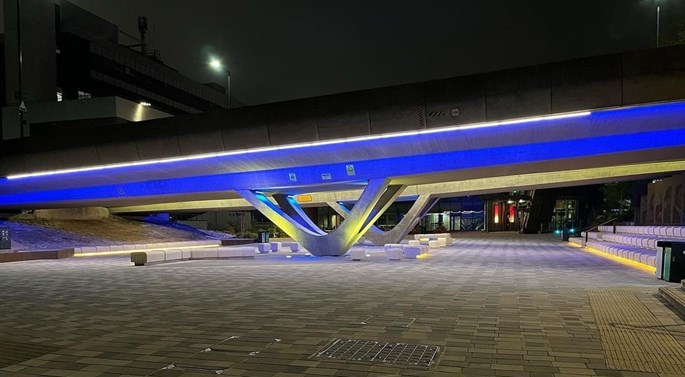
[0,46,685,255]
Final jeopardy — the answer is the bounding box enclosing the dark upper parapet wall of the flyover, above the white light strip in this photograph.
[0,46,685,175]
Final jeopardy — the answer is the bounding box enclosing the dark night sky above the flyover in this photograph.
[0,0,664,104]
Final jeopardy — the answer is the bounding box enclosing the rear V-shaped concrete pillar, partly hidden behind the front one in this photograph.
[327,195,440,245]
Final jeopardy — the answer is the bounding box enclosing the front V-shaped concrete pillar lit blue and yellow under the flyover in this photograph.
[238,179,405,256]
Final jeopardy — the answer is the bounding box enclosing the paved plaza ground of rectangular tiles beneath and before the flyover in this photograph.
[0,234,685,377]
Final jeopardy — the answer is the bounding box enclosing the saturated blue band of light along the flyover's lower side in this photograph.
[0,129,685,208]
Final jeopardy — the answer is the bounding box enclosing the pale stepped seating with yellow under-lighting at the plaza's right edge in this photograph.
[569,225,685,267]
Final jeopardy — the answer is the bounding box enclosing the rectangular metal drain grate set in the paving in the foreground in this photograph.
[313,339,440,368]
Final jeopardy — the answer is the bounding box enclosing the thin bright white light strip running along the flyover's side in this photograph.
[7,111,592,180]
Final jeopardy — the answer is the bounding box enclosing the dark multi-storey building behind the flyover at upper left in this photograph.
[0,0,229,139]
